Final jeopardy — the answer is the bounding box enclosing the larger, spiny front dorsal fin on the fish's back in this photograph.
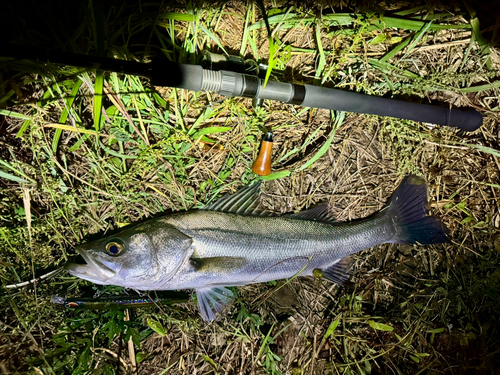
[204,181,276,216]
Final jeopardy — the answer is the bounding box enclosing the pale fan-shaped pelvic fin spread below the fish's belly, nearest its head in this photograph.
[196,286,235,322]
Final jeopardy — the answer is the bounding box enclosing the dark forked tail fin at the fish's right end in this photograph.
[382,175,448,245]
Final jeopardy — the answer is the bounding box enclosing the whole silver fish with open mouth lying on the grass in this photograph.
[65,175,448,322]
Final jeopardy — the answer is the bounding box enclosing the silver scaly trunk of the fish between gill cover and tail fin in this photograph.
[163,211,394,289]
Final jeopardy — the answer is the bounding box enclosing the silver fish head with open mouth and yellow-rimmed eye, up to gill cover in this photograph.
[65,220,192,290]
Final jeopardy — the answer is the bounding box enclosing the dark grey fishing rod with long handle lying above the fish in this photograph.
[0,43,483,131]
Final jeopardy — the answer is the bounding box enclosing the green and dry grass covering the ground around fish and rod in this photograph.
[0,2,500,374]
